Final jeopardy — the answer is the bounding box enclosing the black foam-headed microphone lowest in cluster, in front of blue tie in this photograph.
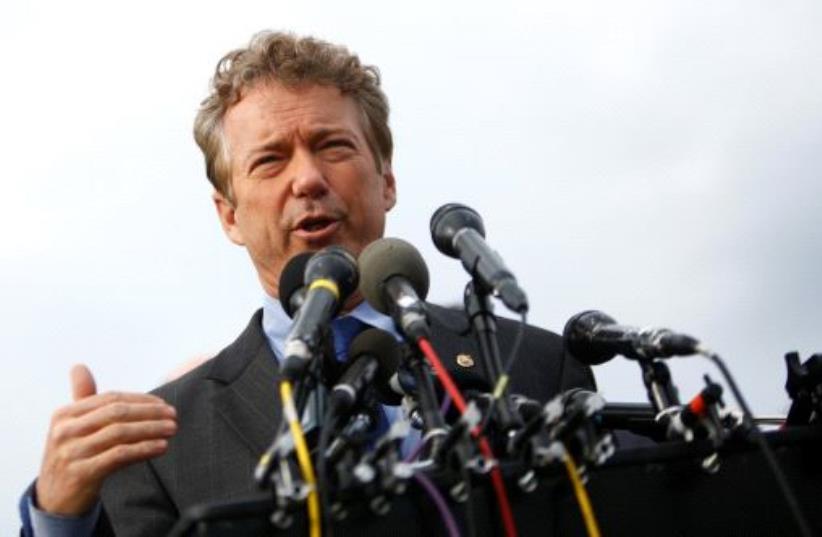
[331,328,400,414]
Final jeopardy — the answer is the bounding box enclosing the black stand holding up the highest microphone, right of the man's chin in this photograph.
[463,280,522,433]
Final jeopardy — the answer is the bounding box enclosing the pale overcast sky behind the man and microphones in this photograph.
[0,0,822,534]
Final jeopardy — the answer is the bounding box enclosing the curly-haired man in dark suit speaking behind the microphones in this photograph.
[20,32,593,537]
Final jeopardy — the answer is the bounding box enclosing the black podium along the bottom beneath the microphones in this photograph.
[170,427,822,537]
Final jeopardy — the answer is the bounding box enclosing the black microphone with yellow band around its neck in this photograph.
[282,246,359,381]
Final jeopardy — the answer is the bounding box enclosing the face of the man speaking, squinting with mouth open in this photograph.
[214,83,396,296]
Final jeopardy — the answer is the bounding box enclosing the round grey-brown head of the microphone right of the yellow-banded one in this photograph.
[358,238,429,315]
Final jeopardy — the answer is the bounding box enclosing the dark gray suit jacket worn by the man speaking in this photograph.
[97,306,594,537]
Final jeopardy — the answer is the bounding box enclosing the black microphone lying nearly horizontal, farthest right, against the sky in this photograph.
[562,310,700,365]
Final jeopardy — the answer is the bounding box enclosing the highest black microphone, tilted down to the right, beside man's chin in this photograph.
[431,203,528,313]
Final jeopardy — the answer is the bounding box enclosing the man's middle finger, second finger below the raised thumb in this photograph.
[51,401,176,443]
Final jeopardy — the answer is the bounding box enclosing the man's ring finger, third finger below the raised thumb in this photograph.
[63,420,177,460]
